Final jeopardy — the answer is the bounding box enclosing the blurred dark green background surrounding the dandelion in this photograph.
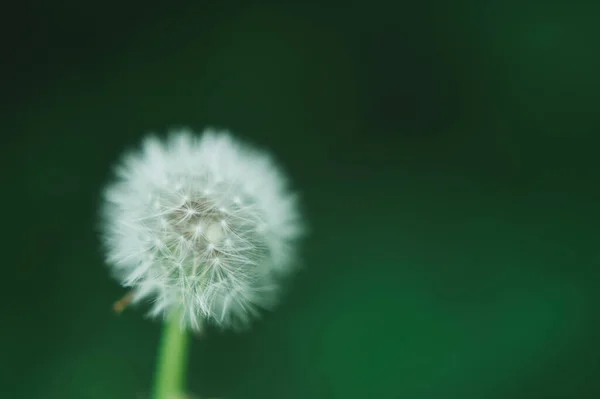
[0,0,600,399]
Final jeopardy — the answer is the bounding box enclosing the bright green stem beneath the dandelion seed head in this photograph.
[154,313,189,399]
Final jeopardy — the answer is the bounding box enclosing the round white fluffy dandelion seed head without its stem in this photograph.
[102,129,303,330]
